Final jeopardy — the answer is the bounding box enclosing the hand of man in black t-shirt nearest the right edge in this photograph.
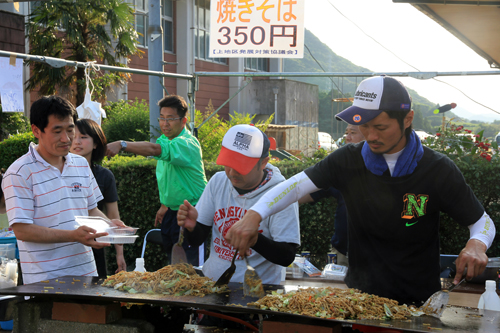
[453,239,488,284]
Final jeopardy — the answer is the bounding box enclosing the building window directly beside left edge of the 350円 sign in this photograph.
[194,0,227,64]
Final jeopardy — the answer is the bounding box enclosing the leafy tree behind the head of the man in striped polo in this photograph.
[26,0,142,105]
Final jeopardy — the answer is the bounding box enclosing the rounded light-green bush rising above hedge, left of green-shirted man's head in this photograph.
[102,99,150,142]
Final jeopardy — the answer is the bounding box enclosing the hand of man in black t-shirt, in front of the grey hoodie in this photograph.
[225,209,262,255]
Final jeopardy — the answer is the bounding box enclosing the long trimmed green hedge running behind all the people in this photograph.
[0,133,500,273]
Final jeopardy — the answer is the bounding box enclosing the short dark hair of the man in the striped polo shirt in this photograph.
[30,96,78,133]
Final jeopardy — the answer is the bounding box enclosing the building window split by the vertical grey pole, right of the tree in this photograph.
[127,0,174,52]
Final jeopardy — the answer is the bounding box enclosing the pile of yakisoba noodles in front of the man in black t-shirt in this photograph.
[248,287,423,320]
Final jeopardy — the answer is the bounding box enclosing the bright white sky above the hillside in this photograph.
[304,0,500,121]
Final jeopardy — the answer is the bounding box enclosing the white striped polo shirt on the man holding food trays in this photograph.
[2,143,102,284]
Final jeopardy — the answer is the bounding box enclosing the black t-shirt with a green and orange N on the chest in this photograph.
[305,143,484,304]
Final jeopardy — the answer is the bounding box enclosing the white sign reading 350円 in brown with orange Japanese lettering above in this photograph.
[209,0,305,58]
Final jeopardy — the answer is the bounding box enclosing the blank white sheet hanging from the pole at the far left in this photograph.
[0,57,24,112]
